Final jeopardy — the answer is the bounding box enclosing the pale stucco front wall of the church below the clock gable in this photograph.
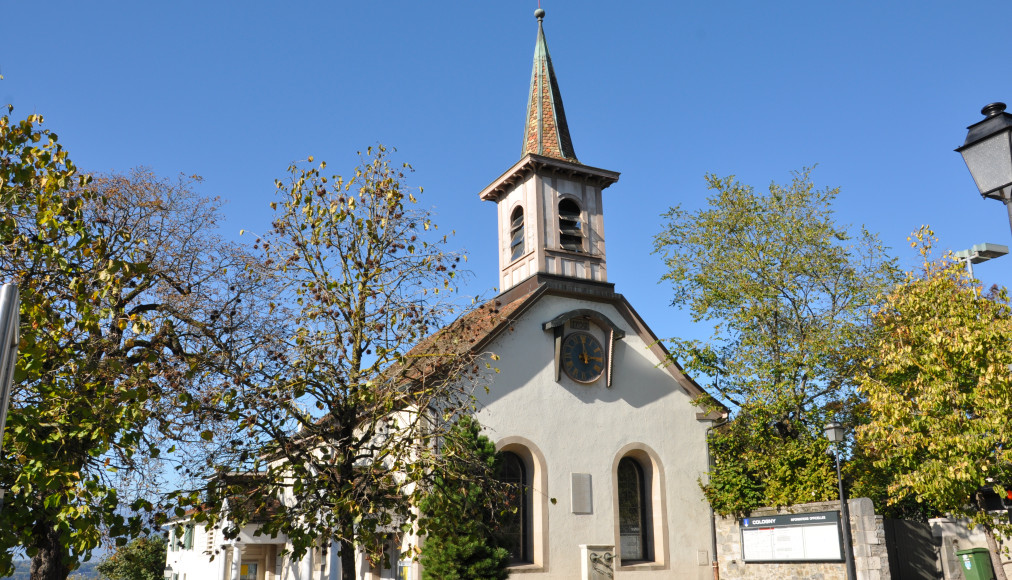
[478,296,712,580]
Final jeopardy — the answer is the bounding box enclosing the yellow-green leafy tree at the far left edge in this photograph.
[0,106,120,578]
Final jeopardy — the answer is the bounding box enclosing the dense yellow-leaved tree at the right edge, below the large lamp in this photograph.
[858,228,1012,579]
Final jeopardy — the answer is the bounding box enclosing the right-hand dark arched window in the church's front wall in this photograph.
[617,458,652,563]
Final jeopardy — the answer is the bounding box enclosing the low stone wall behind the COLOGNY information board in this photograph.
[714,498,891,580]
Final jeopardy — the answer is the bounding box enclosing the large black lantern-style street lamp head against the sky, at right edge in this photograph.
[956,102,1012,234]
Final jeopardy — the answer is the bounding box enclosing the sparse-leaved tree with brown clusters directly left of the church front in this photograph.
[193,146,479,579]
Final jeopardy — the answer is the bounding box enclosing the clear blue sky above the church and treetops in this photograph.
[0,0,1012,348]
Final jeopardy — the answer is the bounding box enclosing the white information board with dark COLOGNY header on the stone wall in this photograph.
[740,511,843,562]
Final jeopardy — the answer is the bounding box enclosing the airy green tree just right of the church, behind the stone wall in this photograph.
[655,170,897,515]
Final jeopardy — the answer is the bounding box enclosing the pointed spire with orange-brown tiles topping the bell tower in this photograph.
[522,8,579,163]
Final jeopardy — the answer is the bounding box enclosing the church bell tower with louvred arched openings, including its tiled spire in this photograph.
[480,8,618,292]
